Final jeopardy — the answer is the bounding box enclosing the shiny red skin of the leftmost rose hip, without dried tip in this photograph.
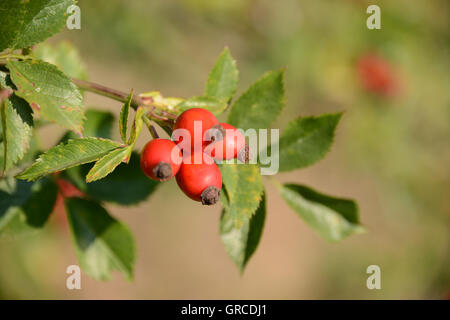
[141,139,182,181]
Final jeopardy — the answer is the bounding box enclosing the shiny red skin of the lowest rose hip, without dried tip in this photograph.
[176,154,222,201]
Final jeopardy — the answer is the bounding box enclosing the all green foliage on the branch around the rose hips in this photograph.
[0,0,363,280]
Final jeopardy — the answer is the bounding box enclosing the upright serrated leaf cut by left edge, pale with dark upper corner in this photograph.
[0,94,33,171]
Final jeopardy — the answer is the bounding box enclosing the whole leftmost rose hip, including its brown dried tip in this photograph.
[141,139,182,181]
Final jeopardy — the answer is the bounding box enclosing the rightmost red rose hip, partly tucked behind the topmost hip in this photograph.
[205,123,245,160]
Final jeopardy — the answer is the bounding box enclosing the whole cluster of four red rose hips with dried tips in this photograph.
[141,108,248,205]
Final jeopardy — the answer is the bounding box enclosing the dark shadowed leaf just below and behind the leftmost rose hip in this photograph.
[63,152,159,205]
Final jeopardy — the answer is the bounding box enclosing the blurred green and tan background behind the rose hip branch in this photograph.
[0,0,450,299]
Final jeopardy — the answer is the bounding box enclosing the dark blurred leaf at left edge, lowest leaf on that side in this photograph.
[0,178,57,237]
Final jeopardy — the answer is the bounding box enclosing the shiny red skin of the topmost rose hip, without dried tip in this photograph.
[173,108,219,152]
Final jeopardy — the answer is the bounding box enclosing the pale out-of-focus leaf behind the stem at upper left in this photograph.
[33,41,88,80]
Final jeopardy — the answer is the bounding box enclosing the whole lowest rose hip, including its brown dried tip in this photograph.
[176,152,222,205]
